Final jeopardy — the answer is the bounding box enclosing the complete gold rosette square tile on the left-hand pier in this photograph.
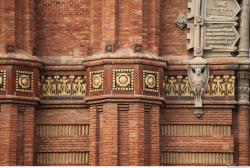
[16,71,33,92]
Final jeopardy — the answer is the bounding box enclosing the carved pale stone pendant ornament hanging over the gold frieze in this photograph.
[188,57,209,118]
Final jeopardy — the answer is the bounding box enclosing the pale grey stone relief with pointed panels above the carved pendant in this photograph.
[187,0,241,56]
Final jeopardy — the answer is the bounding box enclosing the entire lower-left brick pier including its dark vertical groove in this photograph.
[0,104,35,166]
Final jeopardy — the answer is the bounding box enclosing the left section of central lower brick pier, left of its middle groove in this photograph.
[90,103,118,166]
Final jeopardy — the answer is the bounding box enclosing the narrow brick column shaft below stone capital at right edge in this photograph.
[238,108,249,166]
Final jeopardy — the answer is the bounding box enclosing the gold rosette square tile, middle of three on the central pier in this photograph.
[113,69,134,90]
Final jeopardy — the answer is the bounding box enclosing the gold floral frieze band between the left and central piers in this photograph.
[41,75,86,97]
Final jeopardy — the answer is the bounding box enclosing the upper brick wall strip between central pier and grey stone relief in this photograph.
[160,0,188,56]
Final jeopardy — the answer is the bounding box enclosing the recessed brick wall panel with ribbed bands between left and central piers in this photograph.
[35,108,89,165]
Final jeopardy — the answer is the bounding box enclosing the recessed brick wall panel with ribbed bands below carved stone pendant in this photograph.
[160,108,235,165]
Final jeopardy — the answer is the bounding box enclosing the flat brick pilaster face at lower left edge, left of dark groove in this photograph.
[0,104,17,166]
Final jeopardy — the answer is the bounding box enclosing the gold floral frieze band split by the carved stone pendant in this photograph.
[164,75,235,96]
